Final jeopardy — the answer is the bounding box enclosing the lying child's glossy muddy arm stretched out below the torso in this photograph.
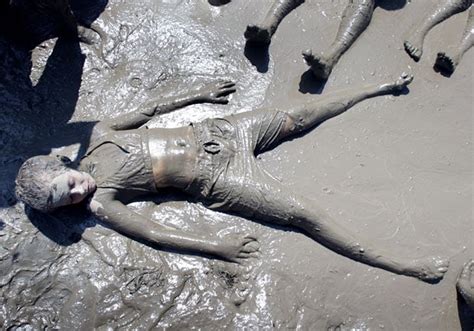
[90,189,258,262]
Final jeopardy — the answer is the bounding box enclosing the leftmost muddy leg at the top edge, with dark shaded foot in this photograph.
[244,0,304,44]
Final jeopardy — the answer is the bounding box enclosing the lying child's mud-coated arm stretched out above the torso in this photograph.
[99,81,236,131]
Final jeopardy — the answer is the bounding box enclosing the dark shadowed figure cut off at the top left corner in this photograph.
[2,0,98,47]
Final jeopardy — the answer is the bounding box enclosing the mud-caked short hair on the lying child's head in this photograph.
[15,155,70,213]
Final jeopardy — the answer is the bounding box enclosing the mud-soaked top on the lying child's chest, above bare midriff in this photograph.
[79,129,157,193]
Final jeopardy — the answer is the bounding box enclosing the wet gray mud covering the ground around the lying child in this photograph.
[0,0,474,330]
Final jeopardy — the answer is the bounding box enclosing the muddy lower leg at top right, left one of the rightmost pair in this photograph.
[403,0,472,62]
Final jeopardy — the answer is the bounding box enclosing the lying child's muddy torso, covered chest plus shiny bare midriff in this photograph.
[80,127,196,193]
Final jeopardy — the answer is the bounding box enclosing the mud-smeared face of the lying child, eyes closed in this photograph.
[51,170,96,208]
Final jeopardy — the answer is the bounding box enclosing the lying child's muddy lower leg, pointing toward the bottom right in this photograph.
[222,168,448,282]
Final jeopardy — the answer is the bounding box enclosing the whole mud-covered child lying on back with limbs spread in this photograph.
[16,75,448,282]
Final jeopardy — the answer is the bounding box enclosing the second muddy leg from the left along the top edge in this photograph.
[303,0,375,79]
